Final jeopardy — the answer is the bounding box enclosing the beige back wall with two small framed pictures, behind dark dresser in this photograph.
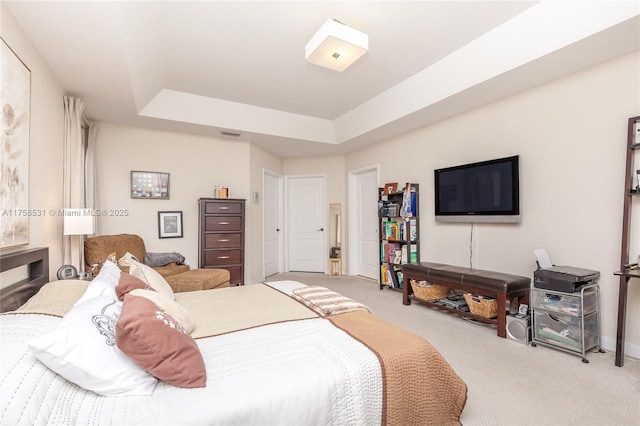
[96,123,251,274]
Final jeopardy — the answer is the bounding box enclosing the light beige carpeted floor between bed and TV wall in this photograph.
[267,272,640,426]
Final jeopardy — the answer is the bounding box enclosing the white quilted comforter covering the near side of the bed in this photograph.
[0,314,383,425]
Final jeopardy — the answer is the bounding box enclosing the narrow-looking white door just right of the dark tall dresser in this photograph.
[263,172,284,277]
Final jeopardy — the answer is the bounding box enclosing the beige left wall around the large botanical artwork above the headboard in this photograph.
[0,2,64,279]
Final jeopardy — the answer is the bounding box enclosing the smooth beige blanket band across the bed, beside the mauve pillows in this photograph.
[175,284,318,339]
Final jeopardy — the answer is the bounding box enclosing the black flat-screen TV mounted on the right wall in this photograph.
[434,155,520,223]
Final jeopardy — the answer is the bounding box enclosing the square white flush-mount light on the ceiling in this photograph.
[304,19,369,71]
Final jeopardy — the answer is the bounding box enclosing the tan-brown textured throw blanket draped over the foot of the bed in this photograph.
[327,311,467,426]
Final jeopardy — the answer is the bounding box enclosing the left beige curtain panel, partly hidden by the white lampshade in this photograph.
[62,96,85,271]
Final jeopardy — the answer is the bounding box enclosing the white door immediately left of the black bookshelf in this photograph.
[350,168,380,280]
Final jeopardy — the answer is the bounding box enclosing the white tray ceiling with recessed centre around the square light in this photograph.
[4,0,640,157]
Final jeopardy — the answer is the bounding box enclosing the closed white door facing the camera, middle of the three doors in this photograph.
[286,176,327,272]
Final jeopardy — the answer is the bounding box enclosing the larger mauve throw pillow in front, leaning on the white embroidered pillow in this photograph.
[116,294,207,388]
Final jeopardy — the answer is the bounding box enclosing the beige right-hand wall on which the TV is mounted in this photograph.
[346,53,640,357]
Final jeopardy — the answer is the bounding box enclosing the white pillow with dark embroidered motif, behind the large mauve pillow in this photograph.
[27,280,158,396]
